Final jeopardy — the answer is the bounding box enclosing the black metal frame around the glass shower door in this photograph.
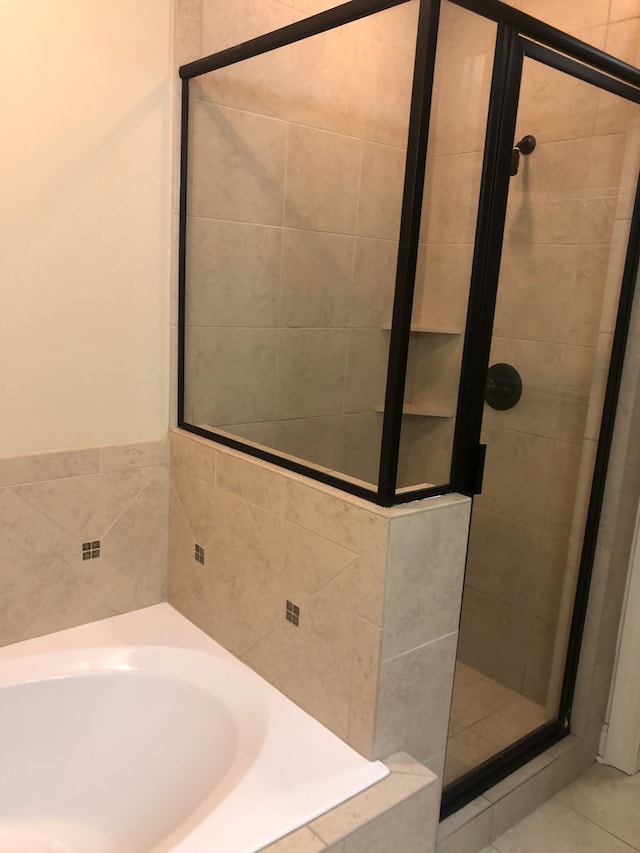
[441,13,640,817]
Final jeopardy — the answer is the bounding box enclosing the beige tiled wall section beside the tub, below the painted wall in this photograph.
[0,438,168,645]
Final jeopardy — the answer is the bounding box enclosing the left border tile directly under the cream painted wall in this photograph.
[0,447,100,486]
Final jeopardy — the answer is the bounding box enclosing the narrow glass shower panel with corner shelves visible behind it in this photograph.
[398,2,497,490]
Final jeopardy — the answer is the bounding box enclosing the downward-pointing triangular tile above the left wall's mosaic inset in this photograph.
[15,468,158,542]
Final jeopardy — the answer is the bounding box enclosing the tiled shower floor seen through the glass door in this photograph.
[444,661,546,785]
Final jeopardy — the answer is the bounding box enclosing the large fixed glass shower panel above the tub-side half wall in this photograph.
[185,0,419,485]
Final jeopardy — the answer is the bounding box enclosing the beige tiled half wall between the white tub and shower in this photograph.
[168,430,470,773]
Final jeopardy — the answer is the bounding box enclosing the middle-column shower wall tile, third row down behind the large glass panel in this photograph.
[280,229,355,328]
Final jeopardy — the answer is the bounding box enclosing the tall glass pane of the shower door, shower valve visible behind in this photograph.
[446,58,640,781]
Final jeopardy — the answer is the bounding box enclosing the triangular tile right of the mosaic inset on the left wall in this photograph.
[100,467,169,603]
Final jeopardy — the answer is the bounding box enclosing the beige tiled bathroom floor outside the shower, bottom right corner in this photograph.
[482,764,640,853]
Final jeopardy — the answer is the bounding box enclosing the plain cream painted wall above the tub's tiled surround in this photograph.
[0,0,171,456]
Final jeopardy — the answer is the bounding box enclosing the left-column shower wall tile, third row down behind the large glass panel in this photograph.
[186,217,282,326]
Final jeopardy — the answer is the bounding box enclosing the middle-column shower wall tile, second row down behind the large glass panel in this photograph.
[284,125,362,234]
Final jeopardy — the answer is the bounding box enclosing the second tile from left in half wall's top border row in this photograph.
[216,450,286,515]
